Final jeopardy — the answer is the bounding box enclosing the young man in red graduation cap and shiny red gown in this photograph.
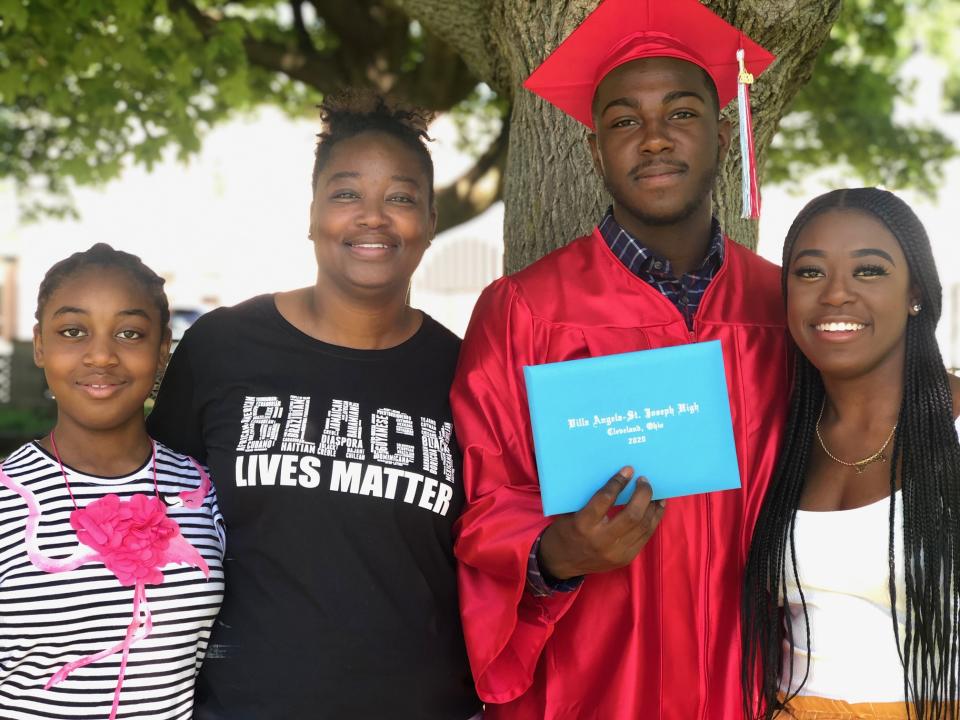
[452,0,788,720]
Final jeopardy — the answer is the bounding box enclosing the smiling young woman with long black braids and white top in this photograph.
[743,188,960,720]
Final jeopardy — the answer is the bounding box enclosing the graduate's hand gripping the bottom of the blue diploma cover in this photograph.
[539,466,666,580]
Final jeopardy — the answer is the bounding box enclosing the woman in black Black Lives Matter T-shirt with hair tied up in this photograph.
[148,94,480,720]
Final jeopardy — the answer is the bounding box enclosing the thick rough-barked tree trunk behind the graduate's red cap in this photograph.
[397,0,841,272]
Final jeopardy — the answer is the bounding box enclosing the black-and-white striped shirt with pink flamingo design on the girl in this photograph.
[0,443,224,720]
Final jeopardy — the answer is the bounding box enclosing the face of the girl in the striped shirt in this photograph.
[33,267,170,431]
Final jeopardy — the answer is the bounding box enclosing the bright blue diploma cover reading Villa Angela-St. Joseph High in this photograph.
[523,340,740,515]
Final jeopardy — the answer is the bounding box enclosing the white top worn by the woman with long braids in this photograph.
[783,420,960,703]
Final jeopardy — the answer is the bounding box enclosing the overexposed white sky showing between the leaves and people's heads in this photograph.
[0,51,960,366]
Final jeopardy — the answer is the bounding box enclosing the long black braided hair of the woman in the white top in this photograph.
[741,188,960,720]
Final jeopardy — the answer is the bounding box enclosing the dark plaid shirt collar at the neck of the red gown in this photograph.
[598,207,723,329]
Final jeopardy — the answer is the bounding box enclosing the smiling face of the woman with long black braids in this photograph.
[787,210,920,378]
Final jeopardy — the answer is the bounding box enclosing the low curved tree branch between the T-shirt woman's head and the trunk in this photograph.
[436,119,510,232]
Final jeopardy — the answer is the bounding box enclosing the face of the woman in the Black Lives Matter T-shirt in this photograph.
[310,132,437,297]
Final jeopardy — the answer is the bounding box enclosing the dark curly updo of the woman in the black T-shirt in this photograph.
[312,89,434,205]
